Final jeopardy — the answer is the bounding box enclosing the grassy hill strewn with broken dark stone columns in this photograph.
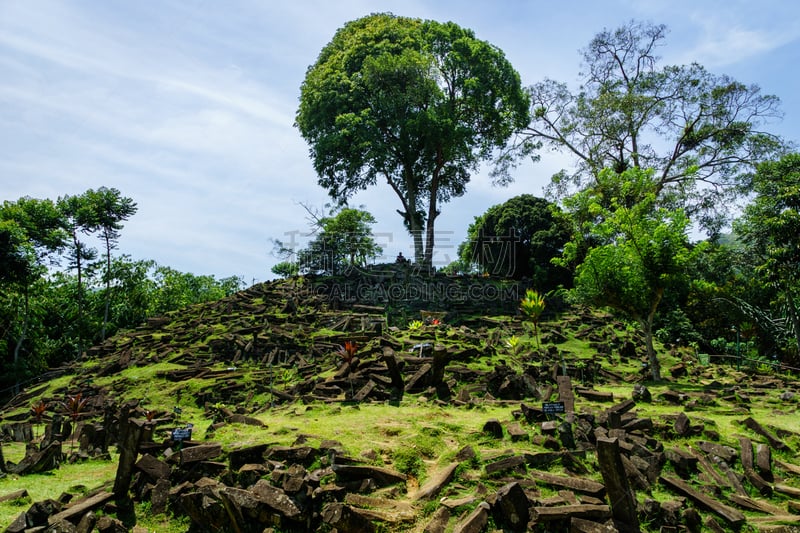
[0,266,800,532]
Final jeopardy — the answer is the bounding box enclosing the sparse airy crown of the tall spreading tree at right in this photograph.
[523,21,781,232]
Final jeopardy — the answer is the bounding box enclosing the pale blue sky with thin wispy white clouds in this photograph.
[0,0,800,285]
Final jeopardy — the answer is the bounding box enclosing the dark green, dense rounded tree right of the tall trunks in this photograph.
[459,194,572,291]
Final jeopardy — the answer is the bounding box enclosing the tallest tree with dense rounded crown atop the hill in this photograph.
[296,13,529,265]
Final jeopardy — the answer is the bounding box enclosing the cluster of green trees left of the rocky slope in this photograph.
[0,187,243,394]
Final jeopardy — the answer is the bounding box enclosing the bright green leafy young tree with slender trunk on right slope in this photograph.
[560,168,690,381]
